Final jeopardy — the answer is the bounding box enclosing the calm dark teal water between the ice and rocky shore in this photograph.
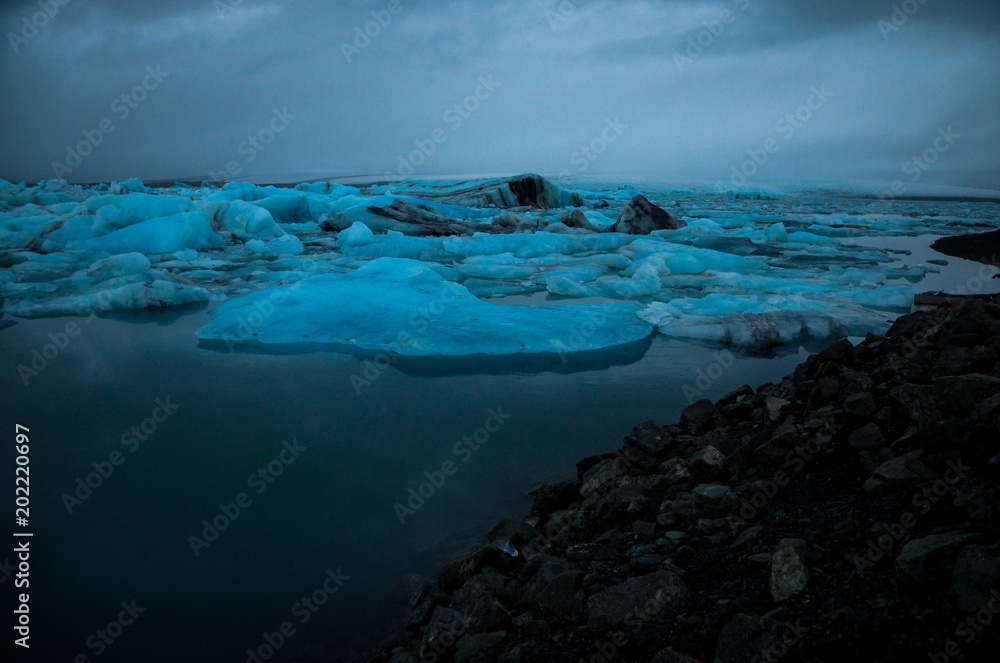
[0,236,992,663]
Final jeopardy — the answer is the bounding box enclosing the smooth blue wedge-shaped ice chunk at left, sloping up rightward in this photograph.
[67,212,222,255]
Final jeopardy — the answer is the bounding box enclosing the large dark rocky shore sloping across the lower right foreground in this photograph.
[363,298,1000,663]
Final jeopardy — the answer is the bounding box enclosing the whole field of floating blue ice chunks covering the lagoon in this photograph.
[0,175,997,356]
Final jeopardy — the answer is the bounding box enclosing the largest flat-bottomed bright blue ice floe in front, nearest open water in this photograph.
[198,258,652,356]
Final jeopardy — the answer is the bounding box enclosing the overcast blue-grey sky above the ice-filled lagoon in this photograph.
[0,0,1000,189]
